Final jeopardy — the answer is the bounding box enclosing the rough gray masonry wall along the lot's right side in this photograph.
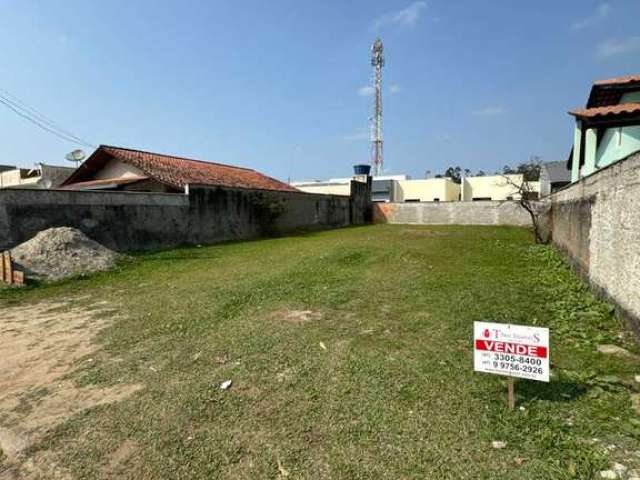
[551,153,640,335]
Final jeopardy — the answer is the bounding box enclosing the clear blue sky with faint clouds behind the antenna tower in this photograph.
[0,0,640,179]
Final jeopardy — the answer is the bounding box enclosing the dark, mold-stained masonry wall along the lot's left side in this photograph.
[0,182,371,251]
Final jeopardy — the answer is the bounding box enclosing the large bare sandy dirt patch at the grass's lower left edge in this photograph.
[0,302,141,480]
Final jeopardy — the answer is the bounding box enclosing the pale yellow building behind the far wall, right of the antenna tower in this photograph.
[461,174,540,202]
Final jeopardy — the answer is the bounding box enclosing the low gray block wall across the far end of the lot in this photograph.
[374,201,531,226]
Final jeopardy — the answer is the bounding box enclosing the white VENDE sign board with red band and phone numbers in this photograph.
[473,322,549,382]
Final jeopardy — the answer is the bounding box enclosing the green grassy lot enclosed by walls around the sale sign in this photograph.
[0,225,640,479]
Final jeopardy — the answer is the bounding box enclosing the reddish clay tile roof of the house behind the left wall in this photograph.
[65,145,298,192]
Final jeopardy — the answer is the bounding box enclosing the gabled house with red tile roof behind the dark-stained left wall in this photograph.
[62,145,298,193]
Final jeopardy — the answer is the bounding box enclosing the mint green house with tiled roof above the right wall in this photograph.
[568,75,640,182]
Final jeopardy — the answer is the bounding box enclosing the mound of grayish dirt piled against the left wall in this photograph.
[11,227,119,281]
